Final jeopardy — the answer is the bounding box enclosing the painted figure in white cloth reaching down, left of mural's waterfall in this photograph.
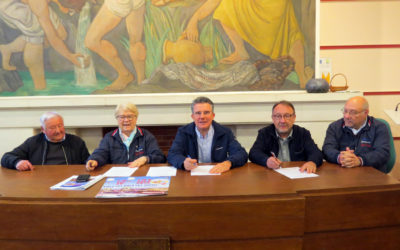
[0,0,86,89]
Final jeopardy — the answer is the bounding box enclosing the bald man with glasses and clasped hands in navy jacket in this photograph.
[322,96,390,172]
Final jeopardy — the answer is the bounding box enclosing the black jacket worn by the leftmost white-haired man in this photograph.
[1,133,89,169]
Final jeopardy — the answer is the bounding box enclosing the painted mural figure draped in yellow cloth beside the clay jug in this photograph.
[182,0,314,88]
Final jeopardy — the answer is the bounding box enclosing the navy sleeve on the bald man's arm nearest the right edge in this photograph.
[357,124,390,169]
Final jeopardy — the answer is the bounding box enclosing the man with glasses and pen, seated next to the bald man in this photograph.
[249,101,322,173]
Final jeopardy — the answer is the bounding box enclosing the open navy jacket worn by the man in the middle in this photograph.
[167,121,247,169]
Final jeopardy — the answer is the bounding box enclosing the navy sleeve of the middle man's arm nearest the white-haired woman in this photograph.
[167,129,187,169]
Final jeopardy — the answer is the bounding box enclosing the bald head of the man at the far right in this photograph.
[343,96,369,129]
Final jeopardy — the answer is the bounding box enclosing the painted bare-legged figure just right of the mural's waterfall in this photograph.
[85,0,146,90]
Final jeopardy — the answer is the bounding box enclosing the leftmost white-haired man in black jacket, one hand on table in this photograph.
[1,112,89,171]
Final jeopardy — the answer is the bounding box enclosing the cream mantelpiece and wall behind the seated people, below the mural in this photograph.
[0,91,361,155]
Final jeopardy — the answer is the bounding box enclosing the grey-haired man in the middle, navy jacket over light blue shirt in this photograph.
[167,97,247,173]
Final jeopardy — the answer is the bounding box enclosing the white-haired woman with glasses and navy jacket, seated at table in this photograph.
[86,103,165,171]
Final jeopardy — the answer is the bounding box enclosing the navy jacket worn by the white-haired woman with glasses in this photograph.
[88,127,165,167]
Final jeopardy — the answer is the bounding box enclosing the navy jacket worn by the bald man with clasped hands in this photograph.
[322,116,390,173]
